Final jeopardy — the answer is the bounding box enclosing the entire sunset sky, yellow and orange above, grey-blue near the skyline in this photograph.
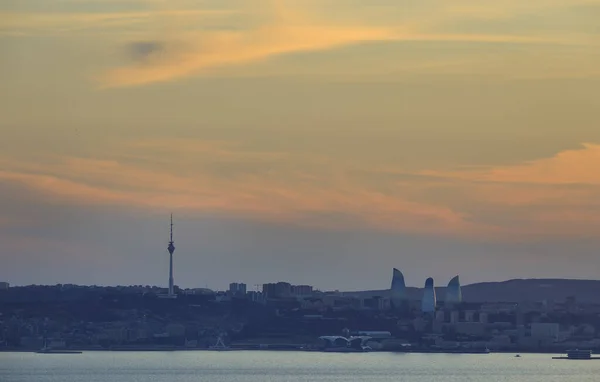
[0,0,600,290]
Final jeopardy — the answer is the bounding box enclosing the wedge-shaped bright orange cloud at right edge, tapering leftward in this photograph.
[420,143,600,237]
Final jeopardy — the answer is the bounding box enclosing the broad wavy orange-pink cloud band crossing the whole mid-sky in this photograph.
[0,141,600,238]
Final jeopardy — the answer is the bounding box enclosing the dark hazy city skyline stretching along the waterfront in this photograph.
[0,269,600,352]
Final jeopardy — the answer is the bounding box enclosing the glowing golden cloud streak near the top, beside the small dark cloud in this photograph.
[97,0,588,88]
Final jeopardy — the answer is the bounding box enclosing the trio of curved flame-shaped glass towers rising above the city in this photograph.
[391,268,462,313]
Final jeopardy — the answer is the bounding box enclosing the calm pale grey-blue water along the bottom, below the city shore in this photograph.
[0,351,600,382]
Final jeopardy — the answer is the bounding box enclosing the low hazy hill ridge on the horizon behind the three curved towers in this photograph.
[346,279,600,304]
